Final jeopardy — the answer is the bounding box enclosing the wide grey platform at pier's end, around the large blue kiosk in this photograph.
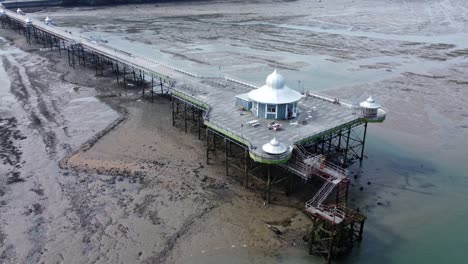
[174,80,364,164]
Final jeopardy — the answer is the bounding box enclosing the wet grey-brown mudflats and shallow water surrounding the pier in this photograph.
[0,0,468,263]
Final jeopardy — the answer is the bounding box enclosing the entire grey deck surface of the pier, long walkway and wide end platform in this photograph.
[1,11,385,164]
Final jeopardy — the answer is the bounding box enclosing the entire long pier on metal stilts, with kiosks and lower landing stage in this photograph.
[0,7,387,262]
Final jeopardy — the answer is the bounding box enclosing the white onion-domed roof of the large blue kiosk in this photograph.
[248,70,302,104]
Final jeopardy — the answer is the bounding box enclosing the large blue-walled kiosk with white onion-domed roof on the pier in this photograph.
[236,70,302,119]
